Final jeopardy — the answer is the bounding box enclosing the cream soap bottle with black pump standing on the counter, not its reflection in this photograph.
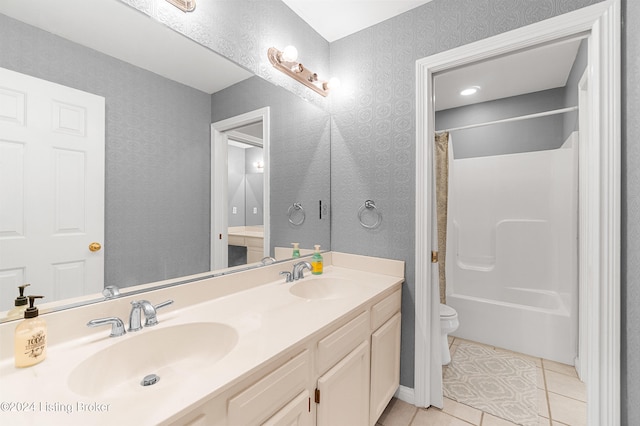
[13,296,47,368]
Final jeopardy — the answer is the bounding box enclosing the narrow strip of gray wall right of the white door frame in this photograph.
[621,0,640,425]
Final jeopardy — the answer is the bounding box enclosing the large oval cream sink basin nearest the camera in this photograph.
[69,322,238,397]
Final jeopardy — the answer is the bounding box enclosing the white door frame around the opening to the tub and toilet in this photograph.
[413,0,621,425]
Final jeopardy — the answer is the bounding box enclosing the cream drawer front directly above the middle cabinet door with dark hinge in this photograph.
[318,312,370,374]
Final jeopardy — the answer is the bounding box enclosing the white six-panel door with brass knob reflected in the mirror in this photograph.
[0,68,105,310]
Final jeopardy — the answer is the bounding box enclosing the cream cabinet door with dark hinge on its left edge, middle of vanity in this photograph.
[316,341,369,426]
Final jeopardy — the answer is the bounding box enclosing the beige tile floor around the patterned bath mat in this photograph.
[376,337,587,426]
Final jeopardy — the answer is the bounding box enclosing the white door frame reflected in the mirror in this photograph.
[210,107,271,270]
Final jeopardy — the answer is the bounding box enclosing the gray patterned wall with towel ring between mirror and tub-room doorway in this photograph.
[331,0,597,387]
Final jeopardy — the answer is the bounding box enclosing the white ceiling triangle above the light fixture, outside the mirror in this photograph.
[282,0,432,42]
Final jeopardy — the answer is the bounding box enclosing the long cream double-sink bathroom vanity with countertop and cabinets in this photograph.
[0,252,404,426]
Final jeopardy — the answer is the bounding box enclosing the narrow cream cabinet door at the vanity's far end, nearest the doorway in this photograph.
[369,313,400,425]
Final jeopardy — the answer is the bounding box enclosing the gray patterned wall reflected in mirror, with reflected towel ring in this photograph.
[211,77,331,251]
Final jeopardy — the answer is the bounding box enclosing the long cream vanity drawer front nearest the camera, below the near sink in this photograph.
[228,350,310,425]
